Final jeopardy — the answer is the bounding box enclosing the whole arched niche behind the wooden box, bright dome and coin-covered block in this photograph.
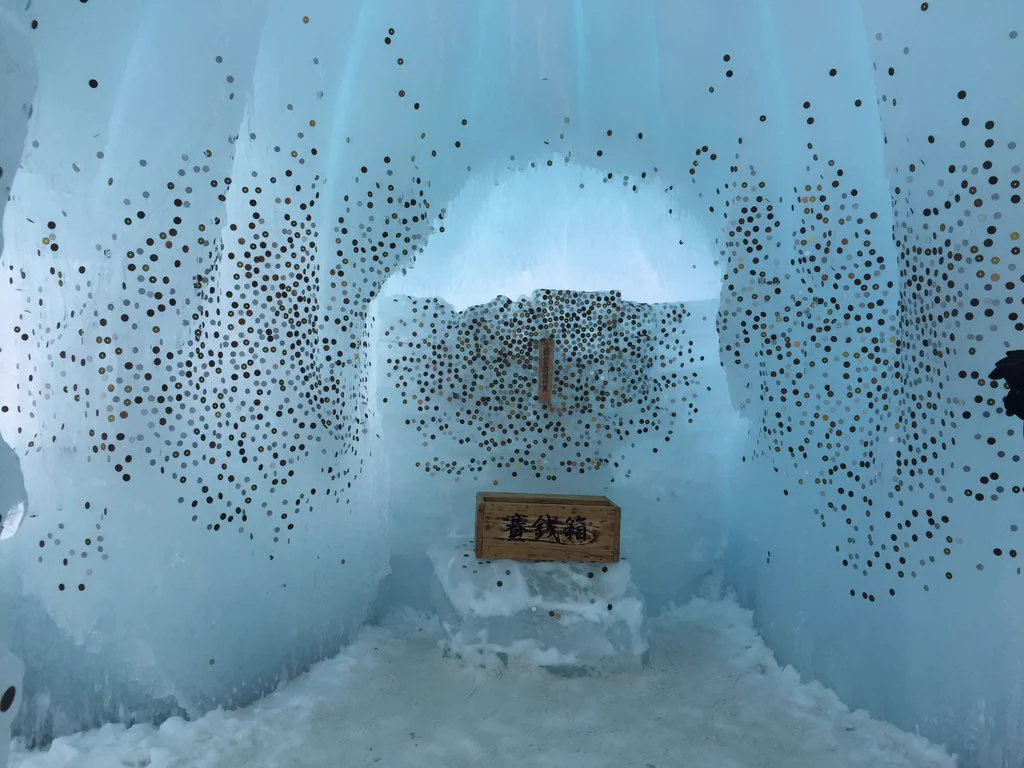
[371,156,745,610]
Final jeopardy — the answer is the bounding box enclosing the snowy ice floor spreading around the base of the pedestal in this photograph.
[11,600,954,768]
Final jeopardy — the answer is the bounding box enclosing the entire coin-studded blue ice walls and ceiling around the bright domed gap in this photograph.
[0,0,1024,765]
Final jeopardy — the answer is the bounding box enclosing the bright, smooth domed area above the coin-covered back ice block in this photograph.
[384,162,721,309]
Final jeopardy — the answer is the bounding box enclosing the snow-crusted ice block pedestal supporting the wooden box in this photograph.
[429,540,648,674]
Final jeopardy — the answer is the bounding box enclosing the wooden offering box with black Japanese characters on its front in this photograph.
[476,492,622,562]
